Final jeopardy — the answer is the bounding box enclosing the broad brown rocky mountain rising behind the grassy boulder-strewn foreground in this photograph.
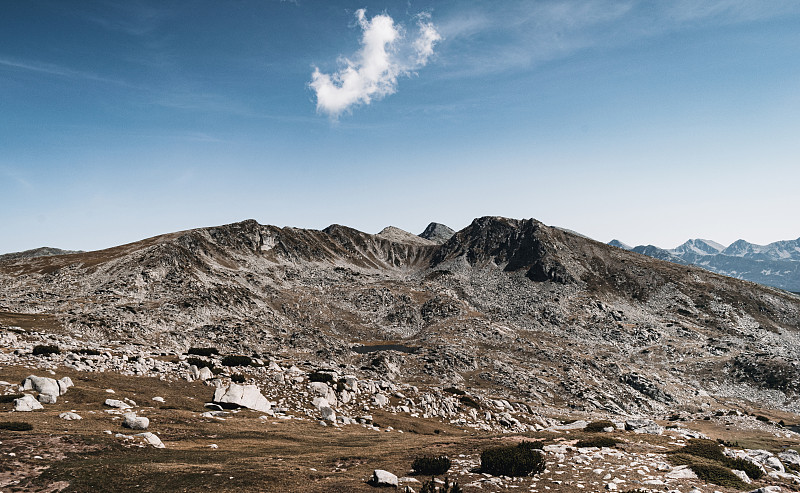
[0,217,800,413]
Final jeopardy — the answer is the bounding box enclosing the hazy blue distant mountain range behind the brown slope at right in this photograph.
[608,238,800,292]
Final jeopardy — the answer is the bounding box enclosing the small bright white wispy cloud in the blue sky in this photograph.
[309,9,442,118]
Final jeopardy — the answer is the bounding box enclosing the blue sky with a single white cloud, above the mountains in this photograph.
[0,0,800,253]
